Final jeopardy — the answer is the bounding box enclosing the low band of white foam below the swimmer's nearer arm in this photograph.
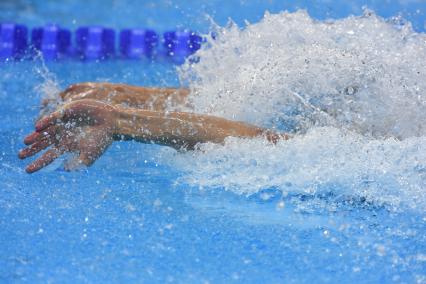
[168,127,426,209]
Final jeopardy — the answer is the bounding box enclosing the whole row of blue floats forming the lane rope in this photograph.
[0,23,203,63]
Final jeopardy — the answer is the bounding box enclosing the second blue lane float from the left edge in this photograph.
[31,25,71,59]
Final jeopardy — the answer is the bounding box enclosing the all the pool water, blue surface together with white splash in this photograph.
[0,0,426,283]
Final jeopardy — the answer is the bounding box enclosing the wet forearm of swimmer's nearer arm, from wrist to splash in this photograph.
[111,107,268,148]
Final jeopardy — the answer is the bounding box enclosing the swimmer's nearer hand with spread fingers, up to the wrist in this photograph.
[19,100,116,173]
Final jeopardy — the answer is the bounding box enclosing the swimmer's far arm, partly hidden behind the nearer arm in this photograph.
[43,82,189,111]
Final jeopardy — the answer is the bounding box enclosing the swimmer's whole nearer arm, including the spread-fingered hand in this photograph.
[19,99,289,173]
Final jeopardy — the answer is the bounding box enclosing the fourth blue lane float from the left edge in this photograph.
[120,29,158,59]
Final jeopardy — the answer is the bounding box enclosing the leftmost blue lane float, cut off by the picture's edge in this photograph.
[0,23,28,60]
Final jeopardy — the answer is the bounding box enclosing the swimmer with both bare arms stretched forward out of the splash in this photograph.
[19,83,289,173]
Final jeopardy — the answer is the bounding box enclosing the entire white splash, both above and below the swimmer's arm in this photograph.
[163,11,426,210]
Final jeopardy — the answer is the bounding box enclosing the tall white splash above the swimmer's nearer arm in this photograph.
[181,11,426,138]
